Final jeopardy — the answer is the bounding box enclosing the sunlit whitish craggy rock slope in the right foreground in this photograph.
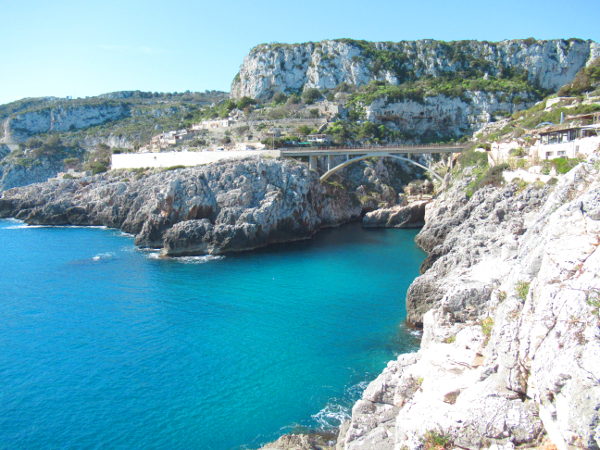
[338,156,600,450]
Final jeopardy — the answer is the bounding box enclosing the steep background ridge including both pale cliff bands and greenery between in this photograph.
[231,39,600,142]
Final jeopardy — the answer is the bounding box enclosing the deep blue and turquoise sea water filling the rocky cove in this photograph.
[0,221,424,449]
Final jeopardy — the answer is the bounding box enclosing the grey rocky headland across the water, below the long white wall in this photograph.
[0,158,361,256]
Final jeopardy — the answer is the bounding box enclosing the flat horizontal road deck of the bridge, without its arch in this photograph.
[280,145,465,156]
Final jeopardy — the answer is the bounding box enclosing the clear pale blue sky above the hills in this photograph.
[0,0,600,104]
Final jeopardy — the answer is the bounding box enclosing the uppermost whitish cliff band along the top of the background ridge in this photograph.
[231,38,600,99]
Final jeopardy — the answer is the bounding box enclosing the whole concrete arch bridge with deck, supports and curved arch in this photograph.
[281,145,465,185]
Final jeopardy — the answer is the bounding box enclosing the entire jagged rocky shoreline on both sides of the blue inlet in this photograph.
[0,155,600,449]
